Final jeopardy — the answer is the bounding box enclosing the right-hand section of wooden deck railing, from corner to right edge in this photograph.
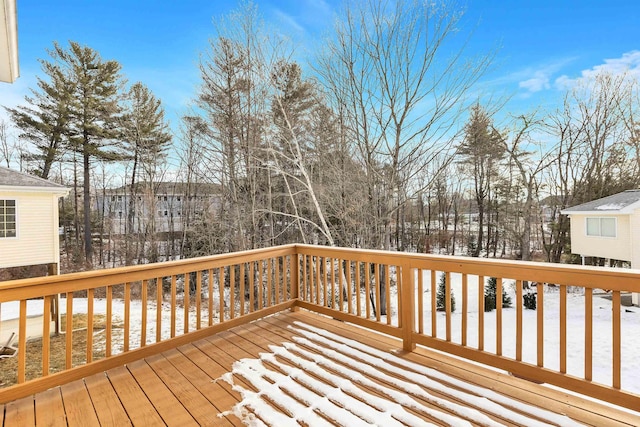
[297,245,640,410]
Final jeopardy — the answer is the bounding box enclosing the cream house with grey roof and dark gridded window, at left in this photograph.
[0,167,69,274]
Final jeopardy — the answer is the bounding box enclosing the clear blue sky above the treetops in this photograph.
[0,0,640,127]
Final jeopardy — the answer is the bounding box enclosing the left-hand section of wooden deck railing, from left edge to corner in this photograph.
[0,245,298,402]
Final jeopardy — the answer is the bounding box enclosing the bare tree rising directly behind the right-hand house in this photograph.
[543,73,638,262]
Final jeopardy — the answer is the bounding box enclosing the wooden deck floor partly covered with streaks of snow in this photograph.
[0,310,640,426]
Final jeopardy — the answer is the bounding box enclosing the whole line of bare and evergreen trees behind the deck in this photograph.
[0,0,640,267]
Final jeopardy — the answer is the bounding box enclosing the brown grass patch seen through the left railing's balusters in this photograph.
[0,314,122,387]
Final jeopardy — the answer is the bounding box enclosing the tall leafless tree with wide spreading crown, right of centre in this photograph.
[318,0,491,249]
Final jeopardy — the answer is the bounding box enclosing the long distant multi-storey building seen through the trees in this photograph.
[97,182,220,235]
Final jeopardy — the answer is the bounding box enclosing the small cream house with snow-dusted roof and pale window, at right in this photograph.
[562,190,640,305]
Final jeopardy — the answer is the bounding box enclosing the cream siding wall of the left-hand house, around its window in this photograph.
[0,192,60,268]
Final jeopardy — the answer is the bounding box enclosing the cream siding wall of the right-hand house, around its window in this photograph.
[571,216,640,261]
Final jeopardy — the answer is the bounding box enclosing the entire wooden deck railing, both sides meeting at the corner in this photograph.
[0,245,640,409]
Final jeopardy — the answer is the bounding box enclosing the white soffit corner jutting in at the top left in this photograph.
[0,0,20,83]
